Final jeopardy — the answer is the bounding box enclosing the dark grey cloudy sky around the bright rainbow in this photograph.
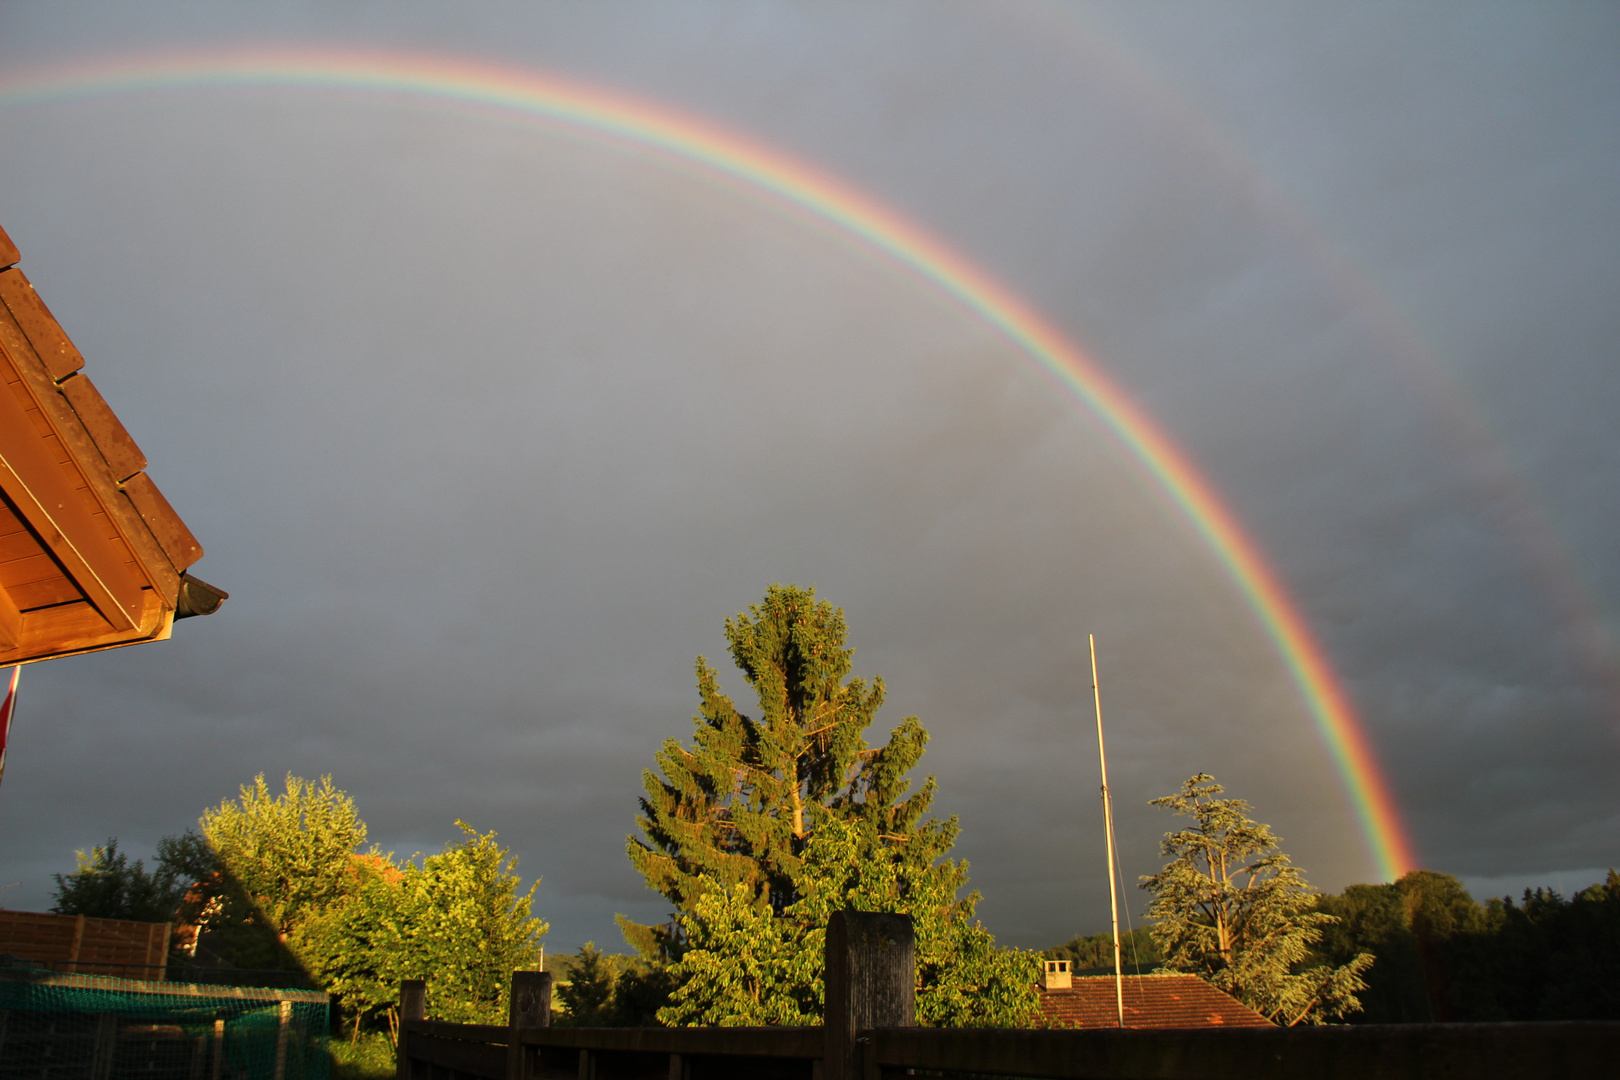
[0,2,1620,950]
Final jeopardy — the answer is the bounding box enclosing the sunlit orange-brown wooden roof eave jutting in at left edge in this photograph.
[0,221,225,665]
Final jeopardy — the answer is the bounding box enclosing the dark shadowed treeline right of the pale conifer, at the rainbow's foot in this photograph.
[1319,870,1620,1023]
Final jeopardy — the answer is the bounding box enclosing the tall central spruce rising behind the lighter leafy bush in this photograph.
[619,585,959,957]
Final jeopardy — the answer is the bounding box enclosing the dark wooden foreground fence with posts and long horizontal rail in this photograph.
[399,912,1620,1080]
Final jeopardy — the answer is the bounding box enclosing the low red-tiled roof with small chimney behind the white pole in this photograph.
[1040,975,1272,1028]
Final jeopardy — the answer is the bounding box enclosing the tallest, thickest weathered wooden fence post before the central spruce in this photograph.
[821,912,917,1080]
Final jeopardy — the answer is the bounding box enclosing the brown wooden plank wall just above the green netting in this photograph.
[0,910,172,980]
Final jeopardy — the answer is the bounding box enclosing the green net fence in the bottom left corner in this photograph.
[0,968,330,1080]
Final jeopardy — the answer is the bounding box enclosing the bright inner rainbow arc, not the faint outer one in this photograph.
[0,49,1418,881]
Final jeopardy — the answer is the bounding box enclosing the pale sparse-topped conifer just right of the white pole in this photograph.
[1142,772,1372,1027]
